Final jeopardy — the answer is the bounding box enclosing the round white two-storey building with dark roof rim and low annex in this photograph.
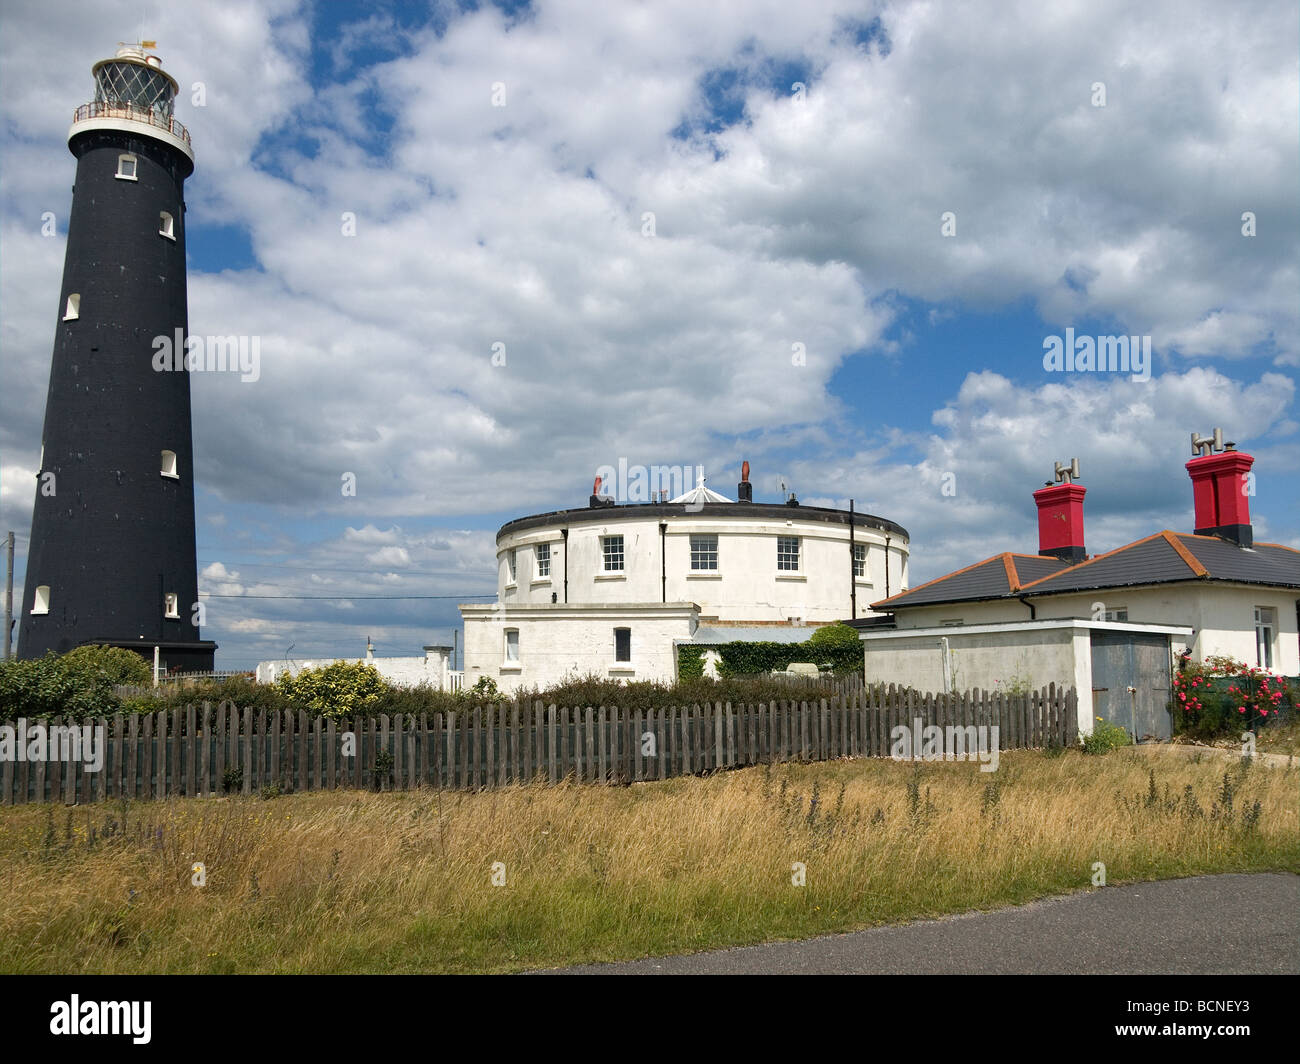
[460,463,909,691]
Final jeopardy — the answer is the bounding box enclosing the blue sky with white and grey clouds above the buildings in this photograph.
[0,0,1300,667]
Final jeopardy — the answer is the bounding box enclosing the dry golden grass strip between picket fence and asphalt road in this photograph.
[0,748,1300,973]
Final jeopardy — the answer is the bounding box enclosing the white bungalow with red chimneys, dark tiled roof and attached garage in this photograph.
[862,431,1300,739]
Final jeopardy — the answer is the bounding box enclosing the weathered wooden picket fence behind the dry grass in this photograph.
[0,684,1076,805]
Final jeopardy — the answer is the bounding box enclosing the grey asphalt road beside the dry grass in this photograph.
[556,873,1300,976]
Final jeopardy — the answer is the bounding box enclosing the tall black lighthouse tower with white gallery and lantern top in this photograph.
[18,46,216,670]
